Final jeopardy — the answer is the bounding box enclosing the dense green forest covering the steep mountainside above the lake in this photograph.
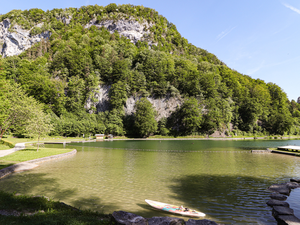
[0,4,300,137]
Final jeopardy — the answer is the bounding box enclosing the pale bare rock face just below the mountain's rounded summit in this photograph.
[84,19,156,45]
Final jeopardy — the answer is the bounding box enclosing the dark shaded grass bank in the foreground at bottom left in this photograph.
[0,192,114,225]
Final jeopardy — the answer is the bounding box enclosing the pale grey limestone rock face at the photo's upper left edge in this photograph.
[0,19,51,57]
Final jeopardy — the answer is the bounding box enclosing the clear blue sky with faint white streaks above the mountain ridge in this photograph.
[0,0,300,101]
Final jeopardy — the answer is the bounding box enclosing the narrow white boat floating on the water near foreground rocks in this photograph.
[145,199,205,217]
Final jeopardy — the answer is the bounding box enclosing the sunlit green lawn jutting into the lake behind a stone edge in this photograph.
[0,147,72,162]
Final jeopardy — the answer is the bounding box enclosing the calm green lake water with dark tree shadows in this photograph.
[0,140,300,224]
